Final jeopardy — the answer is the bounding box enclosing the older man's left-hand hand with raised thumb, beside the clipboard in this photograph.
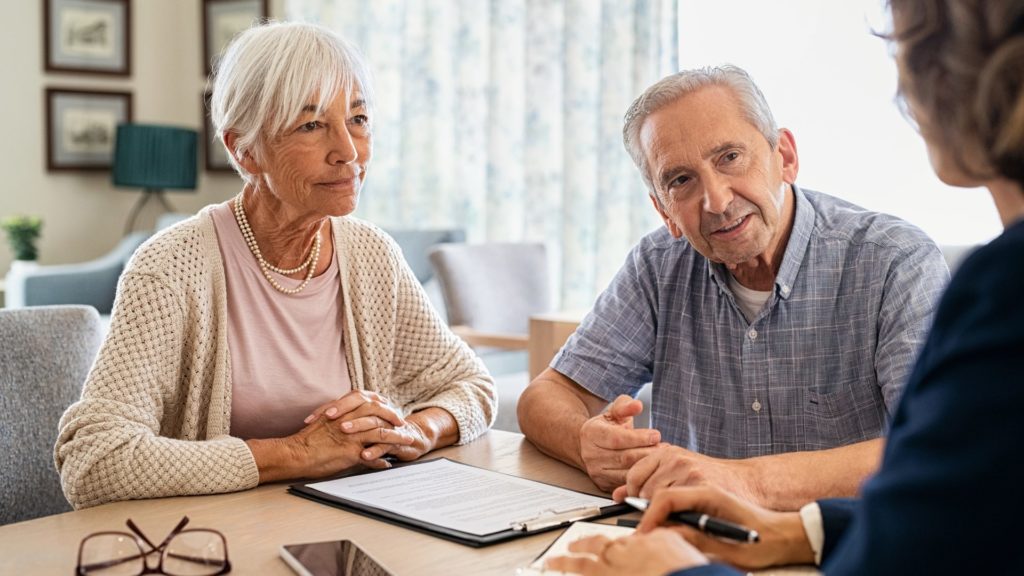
[580,395,662,492]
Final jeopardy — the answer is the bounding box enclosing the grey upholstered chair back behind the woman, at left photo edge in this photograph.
[0,306,102,525]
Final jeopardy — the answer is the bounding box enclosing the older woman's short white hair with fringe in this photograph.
[210,23,373,180]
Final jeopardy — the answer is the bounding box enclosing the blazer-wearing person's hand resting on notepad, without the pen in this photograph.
[544,528,708,576]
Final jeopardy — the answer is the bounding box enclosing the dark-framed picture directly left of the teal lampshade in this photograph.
[45,88,131,171]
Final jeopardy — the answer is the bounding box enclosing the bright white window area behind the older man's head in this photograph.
[679,0,1001,244]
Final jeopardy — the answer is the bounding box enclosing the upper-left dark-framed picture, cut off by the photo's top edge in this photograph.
[43,0,131,76]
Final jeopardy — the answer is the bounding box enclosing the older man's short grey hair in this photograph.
[623,65,778,193]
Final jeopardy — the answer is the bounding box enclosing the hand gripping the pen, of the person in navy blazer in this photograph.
[637,486,814,569]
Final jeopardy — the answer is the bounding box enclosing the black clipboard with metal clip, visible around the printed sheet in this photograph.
[288,458,633,547]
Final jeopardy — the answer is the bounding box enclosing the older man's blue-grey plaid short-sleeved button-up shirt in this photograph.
[551,187,949,458]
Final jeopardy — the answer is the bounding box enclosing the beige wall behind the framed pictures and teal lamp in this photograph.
[0,0,284,277]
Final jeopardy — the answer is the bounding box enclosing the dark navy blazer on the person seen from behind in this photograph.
[675,217,1024,576]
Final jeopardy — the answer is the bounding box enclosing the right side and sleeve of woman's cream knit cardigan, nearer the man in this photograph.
[335,218,497,444]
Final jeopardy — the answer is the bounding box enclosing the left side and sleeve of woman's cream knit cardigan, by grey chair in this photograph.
[54,217,259,508]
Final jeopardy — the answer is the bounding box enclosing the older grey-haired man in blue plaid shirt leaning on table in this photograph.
[518,66,948,509]
